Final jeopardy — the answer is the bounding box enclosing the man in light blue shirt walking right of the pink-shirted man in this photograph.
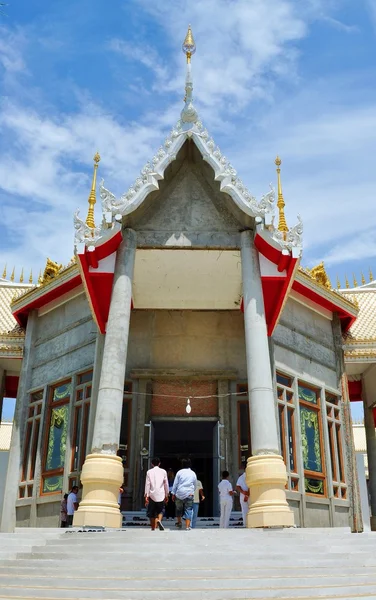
[172,458,197,531]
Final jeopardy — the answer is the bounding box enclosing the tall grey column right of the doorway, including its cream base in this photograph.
[241,231,294,527]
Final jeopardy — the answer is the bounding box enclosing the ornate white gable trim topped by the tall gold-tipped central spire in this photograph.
[74,27,303,253]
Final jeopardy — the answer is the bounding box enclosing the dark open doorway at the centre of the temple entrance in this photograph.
[153,421,217,517]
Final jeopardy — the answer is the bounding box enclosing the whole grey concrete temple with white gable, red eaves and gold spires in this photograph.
[2,29,376,531]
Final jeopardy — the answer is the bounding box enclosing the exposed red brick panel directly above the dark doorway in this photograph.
[151,379,218,417]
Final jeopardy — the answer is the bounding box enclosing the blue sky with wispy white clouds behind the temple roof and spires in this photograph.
[0,0,376,283]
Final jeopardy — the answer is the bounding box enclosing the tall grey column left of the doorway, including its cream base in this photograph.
[73,229,136,527]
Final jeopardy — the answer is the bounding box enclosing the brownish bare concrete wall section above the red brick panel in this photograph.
[126,310,247,379]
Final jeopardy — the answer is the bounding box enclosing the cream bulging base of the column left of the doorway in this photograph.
[73,454,123,528]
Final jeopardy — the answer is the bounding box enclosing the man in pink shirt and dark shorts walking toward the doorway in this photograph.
[145,458,169,531]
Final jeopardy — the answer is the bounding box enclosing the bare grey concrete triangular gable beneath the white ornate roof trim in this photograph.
[128,141,242,248]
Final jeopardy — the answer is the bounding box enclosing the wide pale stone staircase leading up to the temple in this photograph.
[0,527,376,600]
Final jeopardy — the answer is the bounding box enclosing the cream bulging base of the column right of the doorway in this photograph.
[246,454,294,528]
